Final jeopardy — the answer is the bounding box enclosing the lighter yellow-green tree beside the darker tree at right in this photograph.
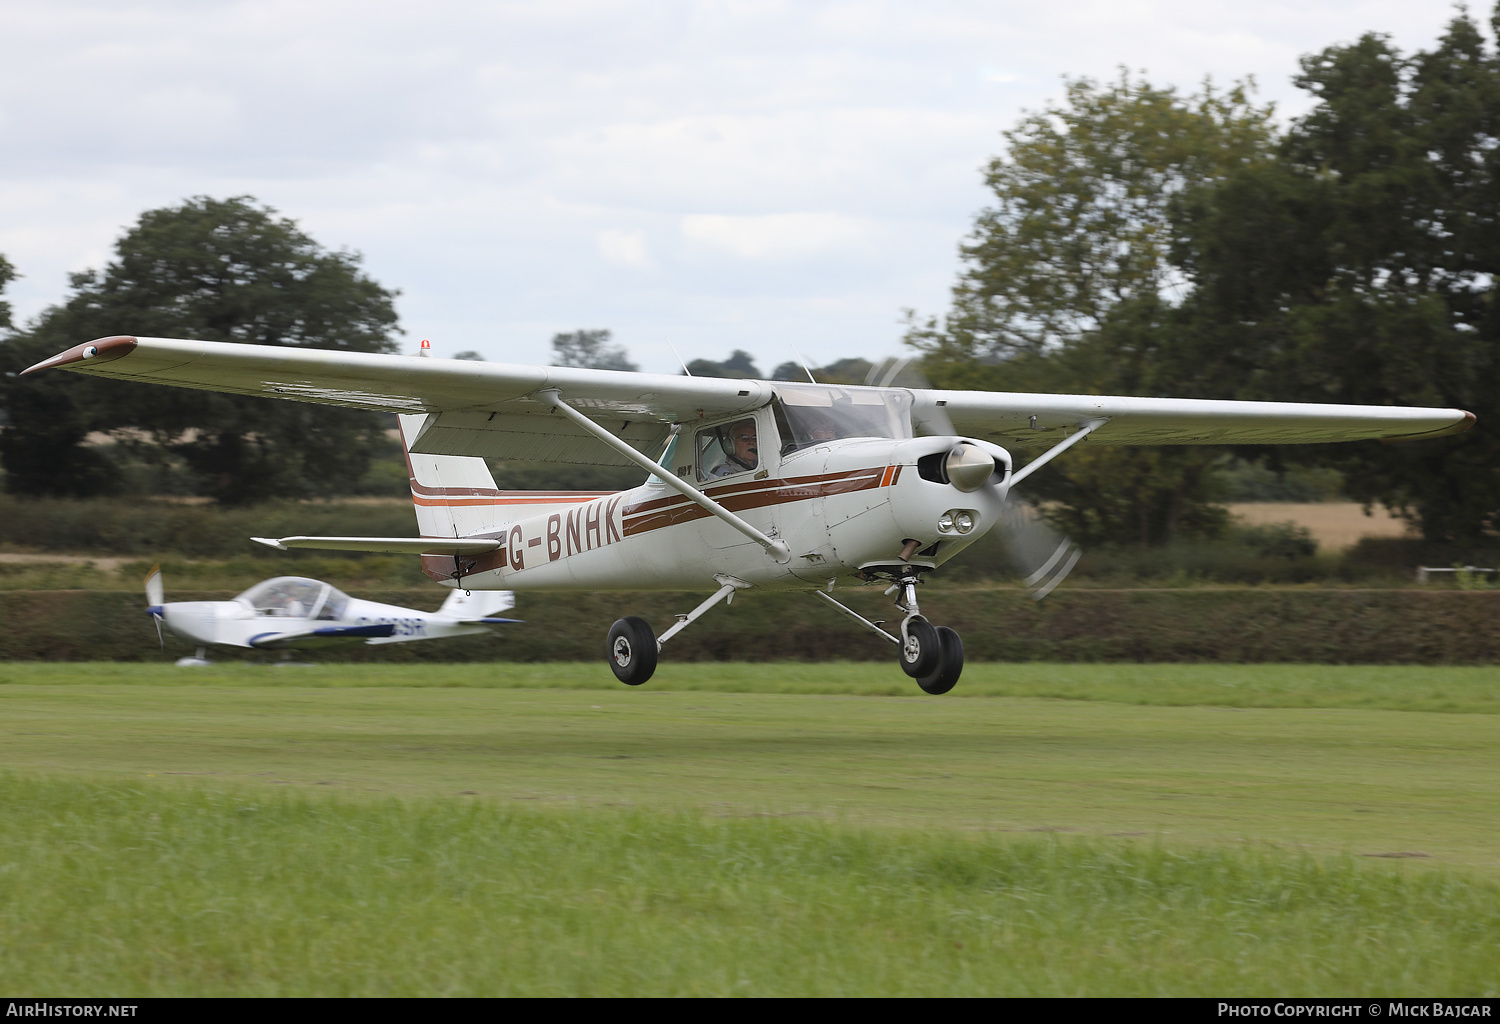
[908,72,1275,543]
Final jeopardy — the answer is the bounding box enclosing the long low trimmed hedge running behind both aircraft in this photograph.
[0,588,1500,664]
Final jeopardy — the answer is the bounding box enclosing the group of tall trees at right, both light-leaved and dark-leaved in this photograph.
[908,7,1500,543]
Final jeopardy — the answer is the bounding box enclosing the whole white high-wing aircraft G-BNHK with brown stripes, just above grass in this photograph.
[26,336,1475,693]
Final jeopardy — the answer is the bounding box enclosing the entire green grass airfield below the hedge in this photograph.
[0,664,1500,996]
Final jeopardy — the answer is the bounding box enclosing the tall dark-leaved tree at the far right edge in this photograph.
[1178,7,1500,540]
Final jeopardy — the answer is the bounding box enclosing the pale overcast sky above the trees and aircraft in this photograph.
[0,0,1488,372]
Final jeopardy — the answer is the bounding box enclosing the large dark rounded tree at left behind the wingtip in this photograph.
[0,196,399,504]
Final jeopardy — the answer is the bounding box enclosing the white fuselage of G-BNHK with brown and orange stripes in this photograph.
[423,436,1010,591]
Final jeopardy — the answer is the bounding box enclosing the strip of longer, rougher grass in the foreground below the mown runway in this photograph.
[0,777,1500,996]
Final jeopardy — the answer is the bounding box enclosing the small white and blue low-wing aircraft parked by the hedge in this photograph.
[146,567,521,666]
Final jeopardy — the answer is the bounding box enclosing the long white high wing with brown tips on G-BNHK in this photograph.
[26,336,1475,449]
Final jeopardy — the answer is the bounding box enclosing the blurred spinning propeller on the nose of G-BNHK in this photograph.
[864,355,1083,601]
